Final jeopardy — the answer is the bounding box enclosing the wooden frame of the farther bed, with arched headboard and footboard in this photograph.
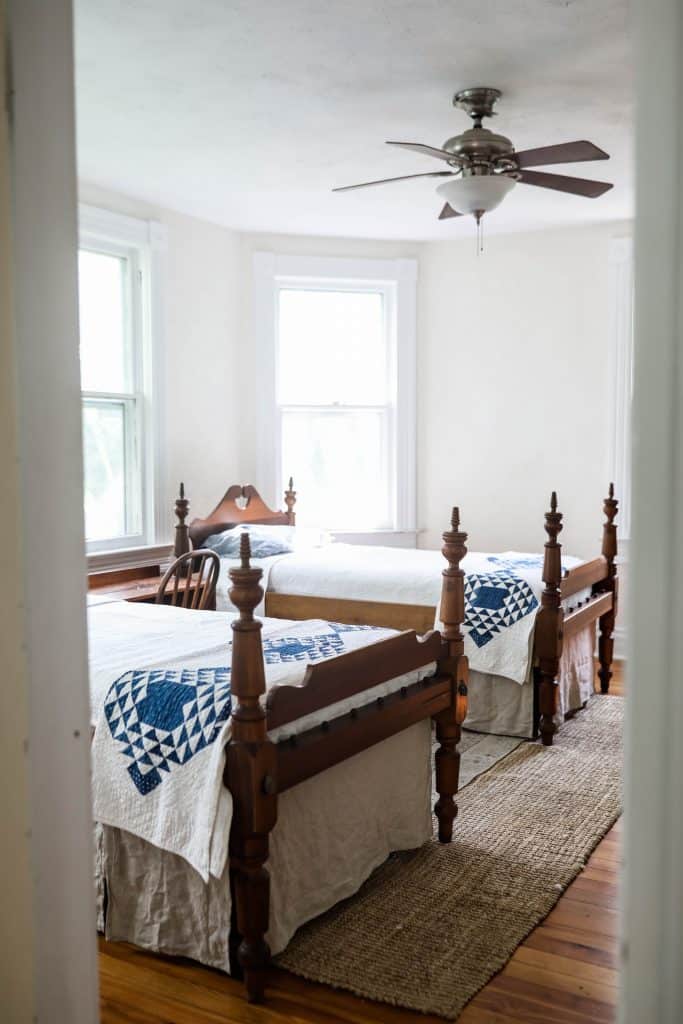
[180,479,618,746]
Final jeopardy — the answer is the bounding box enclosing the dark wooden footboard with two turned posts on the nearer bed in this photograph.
[214,509,468,1001]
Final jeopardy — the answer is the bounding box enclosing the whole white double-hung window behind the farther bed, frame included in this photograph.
[255,254,416,535]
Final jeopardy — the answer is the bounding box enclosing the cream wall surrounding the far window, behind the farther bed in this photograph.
[73,191,631,569]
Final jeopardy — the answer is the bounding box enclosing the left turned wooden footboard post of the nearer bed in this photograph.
[225,534,278,1002]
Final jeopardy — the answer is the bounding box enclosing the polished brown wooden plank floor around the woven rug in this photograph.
[99,673,623,1024]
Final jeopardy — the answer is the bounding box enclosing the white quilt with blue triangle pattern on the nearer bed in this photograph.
[90,605,432,882]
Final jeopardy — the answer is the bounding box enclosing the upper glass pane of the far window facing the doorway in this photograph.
[278,289,388,406]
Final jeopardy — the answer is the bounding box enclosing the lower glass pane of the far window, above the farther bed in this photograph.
[282,411,391,529]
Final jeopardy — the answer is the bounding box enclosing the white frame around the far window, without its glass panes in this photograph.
[254,252,418,545]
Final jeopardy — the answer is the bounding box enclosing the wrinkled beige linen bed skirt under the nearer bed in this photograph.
[95,719,432,973]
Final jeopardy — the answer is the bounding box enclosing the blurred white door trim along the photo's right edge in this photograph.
[620,0,683,1024]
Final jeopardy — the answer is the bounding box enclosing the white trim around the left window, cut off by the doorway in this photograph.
[79,204,167,567]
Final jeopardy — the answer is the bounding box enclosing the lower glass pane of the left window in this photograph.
[83,401,140,541]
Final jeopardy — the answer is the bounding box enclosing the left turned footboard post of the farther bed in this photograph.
[533,490,563,746]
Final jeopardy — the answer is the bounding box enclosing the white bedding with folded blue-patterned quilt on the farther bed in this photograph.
[219,543,588,685]
